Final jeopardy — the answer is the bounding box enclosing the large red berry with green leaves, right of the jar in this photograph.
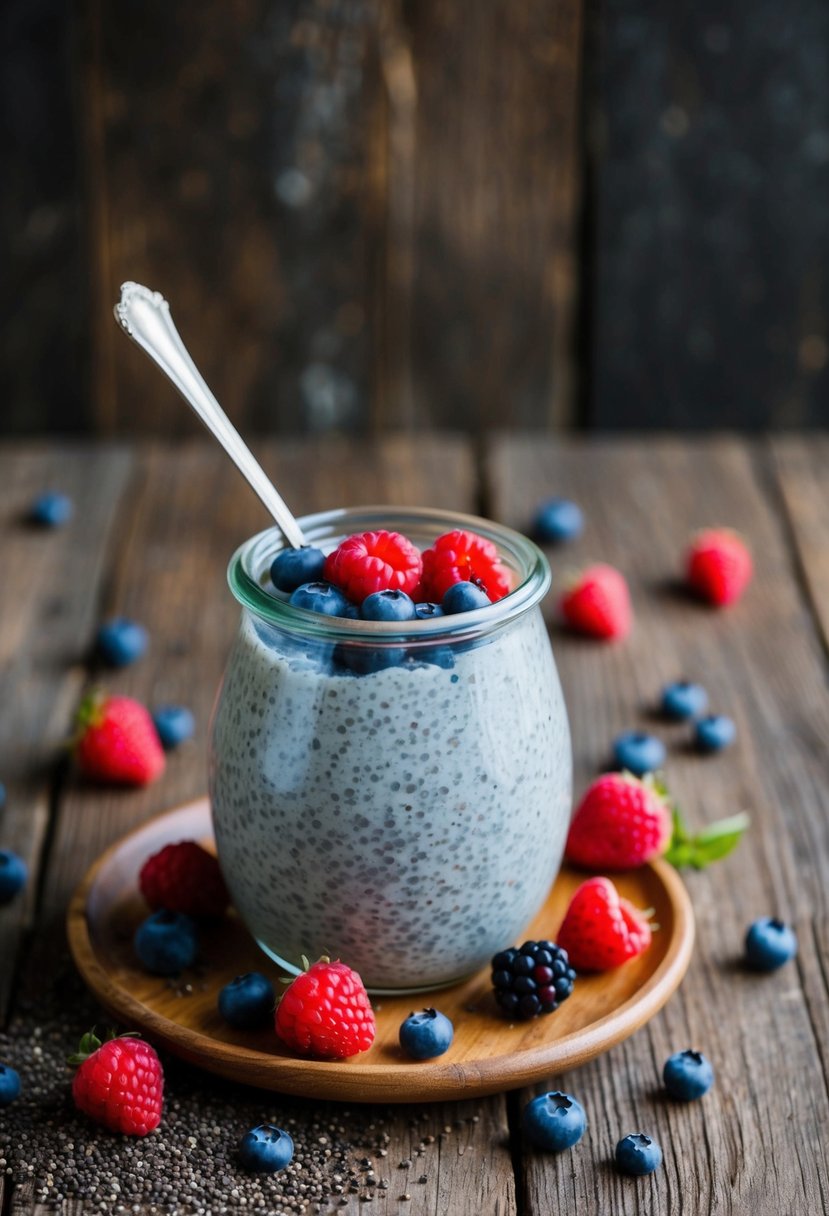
[565,772,673,869]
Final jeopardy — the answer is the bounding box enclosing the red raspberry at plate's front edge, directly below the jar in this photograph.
[275,958,377,1059]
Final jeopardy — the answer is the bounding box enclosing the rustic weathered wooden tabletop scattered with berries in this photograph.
[0,435,829,1216]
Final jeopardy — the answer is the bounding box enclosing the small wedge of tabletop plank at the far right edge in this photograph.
[771,434,829,651]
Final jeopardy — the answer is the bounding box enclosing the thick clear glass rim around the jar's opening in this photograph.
[227,506,552,643]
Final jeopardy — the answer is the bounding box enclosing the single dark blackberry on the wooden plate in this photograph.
[492,941,576,1020]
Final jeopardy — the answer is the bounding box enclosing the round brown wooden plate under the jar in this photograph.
[68,799,694,1102]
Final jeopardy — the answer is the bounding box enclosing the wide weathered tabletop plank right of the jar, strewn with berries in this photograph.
[490,437,829,1214]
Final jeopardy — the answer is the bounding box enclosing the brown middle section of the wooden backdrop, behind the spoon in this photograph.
[80,0,581,435]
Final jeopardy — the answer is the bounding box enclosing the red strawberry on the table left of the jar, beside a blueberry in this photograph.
[74,693,165,786]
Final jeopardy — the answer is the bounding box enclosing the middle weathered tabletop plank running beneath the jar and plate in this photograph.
[3,437,515,1216]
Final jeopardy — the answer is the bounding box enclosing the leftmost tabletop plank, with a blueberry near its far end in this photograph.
[0,445,130,1021]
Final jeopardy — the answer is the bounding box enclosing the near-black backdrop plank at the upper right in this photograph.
[586,0,829,429]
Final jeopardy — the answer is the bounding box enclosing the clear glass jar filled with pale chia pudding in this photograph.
[209,507,571,992]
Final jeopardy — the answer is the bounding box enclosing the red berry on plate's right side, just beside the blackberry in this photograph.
[556,878,652,972]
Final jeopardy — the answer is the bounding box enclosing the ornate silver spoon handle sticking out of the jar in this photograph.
[114,283,306,548]
